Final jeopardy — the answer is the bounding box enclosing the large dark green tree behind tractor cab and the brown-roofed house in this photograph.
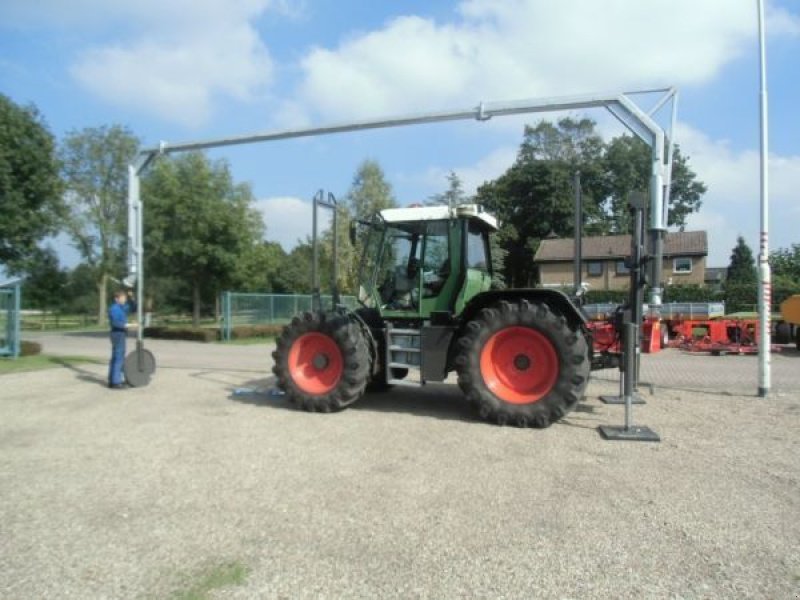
[476,118,705,287]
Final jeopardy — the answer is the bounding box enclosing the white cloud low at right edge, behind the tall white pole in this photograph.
[676,125,800,266]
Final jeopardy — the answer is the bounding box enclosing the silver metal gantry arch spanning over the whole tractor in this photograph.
[127,87,678,376]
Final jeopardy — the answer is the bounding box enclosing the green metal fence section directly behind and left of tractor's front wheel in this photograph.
[221,292,357,340]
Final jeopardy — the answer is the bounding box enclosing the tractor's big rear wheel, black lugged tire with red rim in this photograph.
[456,300,591,428]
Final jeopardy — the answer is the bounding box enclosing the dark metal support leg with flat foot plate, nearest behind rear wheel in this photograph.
[598,194,661,442]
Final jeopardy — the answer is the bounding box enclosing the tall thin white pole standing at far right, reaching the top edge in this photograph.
[758,0,772,397]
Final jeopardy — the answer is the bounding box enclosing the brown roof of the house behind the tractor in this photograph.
[533,231,708,262]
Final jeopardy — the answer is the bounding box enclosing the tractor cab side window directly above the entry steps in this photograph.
[378,224,422,310]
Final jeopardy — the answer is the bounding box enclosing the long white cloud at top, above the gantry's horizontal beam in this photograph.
[300,0,796,118]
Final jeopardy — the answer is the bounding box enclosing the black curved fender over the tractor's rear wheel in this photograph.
[447,288,592,371]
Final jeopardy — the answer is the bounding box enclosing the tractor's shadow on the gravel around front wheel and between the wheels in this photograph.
[229,377,480,423]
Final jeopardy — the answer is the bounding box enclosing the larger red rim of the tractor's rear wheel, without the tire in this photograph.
[481,327,559,404]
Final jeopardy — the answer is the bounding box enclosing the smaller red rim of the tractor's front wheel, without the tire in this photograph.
[288,333,344,395]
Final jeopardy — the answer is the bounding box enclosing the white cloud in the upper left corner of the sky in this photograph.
[5,0,300,127]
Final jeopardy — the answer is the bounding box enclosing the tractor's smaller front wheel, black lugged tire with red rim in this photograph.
[272,312,370,412]
